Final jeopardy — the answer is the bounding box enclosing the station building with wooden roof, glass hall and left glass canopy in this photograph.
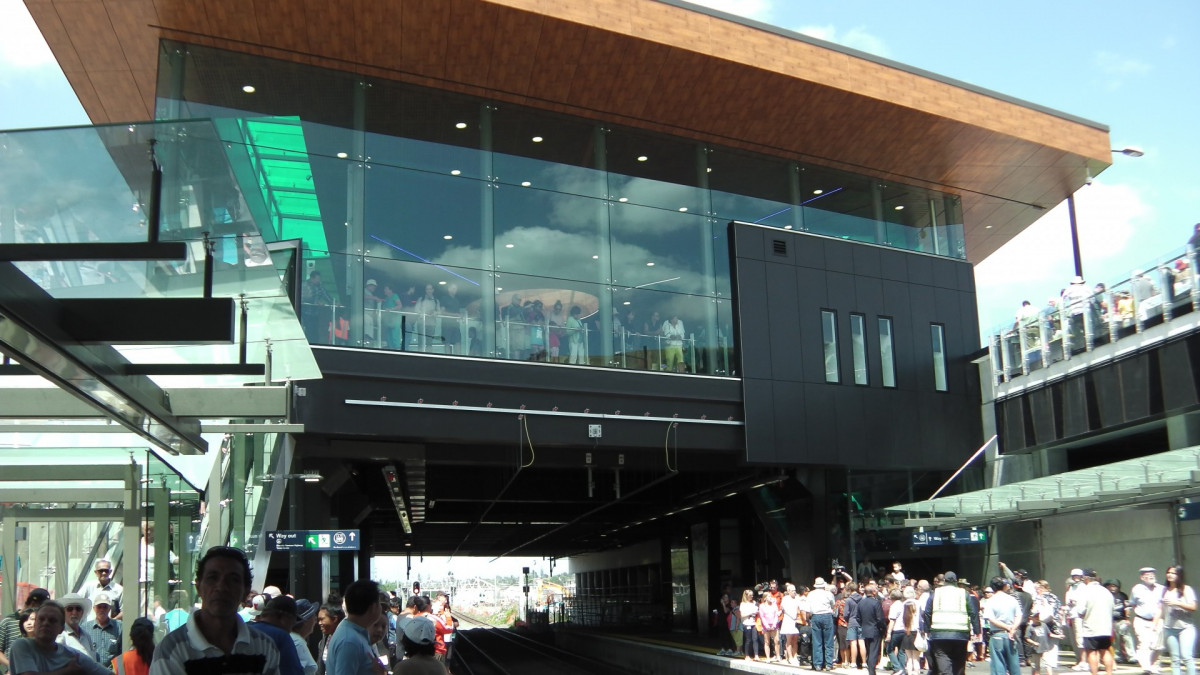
[9,0,1190,643]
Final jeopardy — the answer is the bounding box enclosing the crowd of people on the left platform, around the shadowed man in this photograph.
[0,546,458,675]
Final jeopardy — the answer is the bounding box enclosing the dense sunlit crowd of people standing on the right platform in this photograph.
[712,562,1196,675]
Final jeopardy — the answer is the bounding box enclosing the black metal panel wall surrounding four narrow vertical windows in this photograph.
[731,223,982,468]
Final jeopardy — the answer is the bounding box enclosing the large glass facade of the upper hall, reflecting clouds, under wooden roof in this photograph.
[156,41,965,376]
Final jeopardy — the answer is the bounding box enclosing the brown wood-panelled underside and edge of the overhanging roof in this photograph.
[25,0,1111,261]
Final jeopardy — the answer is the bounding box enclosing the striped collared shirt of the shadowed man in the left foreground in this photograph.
[150,610,280,675]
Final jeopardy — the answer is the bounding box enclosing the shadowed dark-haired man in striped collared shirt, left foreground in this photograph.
[150,546,280,675]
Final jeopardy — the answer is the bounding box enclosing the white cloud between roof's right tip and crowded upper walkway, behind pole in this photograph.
[974,180,1154,338]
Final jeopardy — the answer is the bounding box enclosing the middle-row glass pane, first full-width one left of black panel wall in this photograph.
[610,203,710,295]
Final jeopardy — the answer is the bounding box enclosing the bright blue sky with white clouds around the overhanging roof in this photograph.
[0,0,1200,331]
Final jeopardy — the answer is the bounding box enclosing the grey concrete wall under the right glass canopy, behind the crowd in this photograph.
[1046,504,1176,592]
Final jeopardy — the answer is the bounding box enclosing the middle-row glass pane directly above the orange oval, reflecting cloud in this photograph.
[492,185,610,282]
